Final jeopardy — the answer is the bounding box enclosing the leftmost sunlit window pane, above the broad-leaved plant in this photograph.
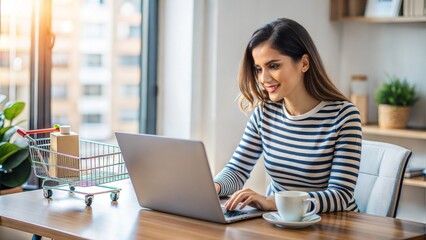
[0,0,32,129]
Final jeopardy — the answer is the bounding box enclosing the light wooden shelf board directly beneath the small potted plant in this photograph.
[362,125,426,140]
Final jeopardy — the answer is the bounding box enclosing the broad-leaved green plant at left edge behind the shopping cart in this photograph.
[0,94,31,189]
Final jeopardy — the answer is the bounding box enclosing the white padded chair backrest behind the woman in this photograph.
[355,140,411,217]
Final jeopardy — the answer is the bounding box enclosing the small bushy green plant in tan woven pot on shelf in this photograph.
[375,76,418,128]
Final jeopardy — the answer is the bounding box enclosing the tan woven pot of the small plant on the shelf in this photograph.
[379,104,411,129]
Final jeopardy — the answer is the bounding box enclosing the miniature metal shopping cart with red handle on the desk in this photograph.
[17,128,129,206]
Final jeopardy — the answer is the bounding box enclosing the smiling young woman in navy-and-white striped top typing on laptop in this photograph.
[215,18,362,212]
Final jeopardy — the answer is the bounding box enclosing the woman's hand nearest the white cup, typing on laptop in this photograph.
[224,188,276,211]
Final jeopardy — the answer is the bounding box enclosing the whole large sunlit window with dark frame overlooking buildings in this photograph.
[0,0,158,186]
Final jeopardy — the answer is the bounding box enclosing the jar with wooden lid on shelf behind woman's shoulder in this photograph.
[351,75,368,124]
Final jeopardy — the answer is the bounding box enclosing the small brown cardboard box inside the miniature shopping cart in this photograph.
[49,132,80,178]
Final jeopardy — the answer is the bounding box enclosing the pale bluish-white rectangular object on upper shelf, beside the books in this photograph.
[365,0,401,17]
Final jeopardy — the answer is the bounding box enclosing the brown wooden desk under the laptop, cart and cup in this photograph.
[0,180,426,240]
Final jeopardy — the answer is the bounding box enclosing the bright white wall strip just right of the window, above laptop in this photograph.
[158,0,194,138]
